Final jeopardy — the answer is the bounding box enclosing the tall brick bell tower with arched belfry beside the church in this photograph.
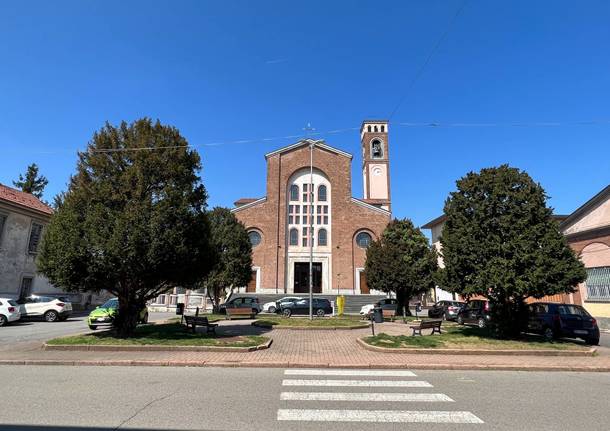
[360,120,391,211]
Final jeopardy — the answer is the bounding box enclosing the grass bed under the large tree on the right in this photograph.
[364,323,588,350]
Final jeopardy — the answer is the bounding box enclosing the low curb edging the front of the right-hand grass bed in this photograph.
[356,338,597,357]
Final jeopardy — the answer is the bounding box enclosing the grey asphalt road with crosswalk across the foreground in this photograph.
[0,366,610,431]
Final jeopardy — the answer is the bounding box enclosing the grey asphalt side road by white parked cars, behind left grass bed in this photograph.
[0,313,174,349]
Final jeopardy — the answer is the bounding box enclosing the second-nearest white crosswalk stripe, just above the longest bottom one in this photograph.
[280,392,453,403]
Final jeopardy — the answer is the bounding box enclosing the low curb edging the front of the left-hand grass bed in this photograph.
[42,338,273,352]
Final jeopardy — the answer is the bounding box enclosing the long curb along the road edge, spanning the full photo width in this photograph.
[0,359,610,372]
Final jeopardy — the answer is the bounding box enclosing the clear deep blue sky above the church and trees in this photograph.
[0,0,610,228]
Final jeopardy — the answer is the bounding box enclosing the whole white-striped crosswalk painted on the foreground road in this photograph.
[277,369,483,424]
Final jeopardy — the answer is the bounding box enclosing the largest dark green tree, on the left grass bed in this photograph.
[38,119,211,337]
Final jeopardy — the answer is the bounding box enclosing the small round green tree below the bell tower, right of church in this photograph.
[365,219,438,315]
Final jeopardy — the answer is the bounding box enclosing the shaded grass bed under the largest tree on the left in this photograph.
[47,323,269,347]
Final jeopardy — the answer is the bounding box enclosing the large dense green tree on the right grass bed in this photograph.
[441,165,586,337]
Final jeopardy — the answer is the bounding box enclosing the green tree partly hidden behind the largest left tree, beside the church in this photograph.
[204,207,252,311]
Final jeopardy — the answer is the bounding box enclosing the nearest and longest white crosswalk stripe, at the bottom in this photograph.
[277,409,484,424]
